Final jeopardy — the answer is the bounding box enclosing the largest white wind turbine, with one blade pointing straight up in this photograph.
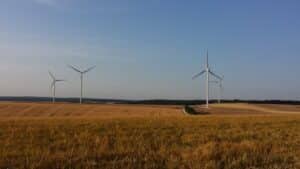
[193,50,222,108]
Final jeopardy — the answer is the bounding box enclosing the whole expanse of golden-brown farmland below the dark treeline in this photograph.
[0,102,300,169]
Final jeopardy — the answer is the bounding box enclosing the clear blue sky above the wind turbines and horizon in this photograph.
[0,0,300,100]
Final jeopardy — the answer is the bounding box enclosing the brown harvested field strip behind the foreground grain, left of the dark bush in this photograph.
[0,102,183,118]
